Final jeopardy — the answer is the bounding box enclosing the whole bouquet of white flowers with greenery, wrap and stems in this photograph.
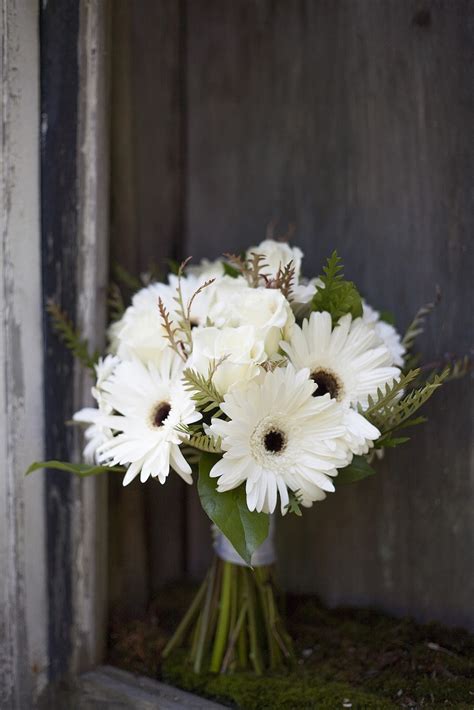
[30,239,462,672]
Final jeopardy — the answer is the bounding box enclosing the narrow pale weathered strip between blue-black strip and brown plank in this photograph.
[72,0,109,670]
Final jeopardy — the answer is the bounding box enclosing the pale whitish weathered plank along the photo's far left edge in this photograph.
[0,1,48,710]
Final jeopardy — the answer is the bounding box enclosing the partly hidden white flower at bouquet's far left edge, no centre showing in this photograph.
[73,355,120,464]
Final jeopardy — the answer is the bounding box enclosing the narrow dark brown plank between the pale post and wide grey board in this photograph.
[110,0,185,615]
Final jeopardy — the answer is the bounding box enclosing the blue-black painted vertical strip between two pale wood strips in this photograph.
[40,2,79,679]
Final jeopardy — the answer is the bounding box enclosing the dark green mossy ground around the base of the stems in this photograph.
[109,585,474,710]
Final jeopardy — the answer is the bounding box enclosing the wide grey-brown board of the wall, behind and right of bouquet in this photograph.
[185,0,474,627]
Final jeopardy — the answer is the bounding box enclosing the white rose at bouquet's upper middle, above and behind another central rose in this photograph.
[209,286,295,357]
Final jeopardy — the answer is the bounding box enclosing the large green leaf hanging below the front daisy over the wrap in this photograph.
[198,454,269,566]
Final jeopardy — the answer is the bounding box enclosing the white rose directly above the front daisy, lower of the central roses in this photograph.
[188,325,266,394]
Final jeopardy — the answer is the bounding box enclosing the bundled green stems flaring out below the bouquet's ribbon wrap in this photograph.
[163,555,294,675]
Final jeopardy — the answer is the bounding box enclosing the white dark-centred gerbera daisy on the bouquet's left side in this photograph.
[98,349,201,486]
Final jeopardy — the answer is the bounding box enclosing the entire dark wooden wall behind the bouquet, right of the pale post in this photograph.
[110,0,474,627]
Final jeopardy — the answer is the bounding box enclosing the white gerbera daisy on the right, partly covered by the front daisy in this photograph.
[280,312,400,454]
